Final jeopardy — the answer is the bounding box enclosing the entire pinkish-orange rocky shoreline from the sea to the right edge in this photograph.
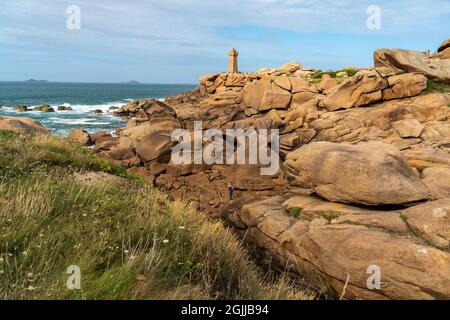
[0,40,450,299]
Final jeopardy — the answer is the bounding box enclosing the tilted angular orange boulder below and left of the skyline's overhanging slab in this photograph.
[320,70,387,111]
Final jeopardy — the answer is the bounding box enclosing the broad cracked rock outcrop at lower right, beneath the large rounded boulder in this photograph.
[226,191,450,299]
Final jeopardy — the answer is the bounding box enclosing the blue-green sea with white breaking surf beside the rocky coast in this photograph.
[0,82,195,136]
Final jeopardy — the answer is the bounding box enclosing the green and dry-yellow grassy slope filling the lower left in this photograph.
[0,131,311,300]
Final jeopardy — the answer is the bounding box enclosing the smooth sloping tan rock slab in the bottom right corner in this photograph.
[302,224,450,299]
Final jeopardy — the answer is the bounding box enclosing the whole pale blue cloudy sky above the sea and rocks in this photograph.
[0,0,450,84]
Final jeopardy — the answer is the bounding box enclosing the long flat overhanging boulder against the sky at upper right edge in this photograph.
[374,49,450,83]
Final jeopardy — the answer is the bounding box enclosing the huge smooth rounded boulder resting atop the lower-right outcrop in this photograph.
[284,142,430,205]
